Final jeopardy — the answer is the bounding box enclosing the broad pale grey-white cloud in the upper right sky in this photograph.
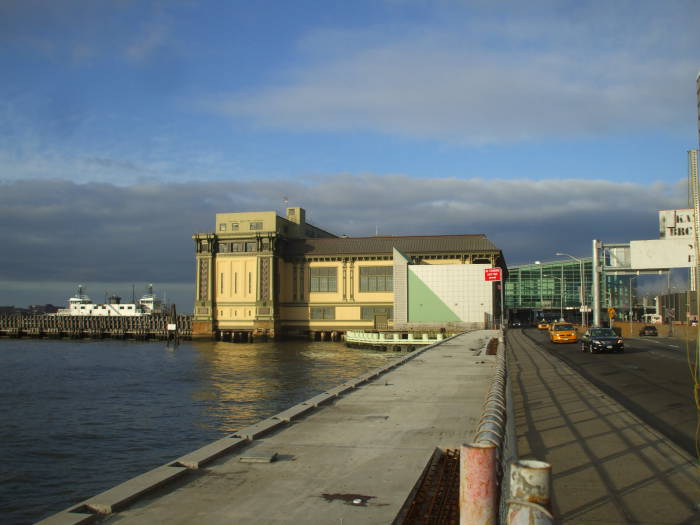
[215,4,700,144]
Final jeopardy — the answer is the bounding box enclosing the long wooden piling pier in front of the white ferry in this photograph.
[0,314,192,339]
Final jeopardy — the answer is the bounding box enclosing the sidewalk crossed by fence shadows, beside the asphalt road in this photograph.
[507,330,700,525]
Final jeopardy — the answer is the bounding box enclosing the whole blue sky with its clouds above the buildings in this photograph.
[0,0,700,311]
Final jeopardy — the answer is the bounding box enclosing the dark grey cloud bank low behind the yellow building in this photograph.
[0,174,685,288]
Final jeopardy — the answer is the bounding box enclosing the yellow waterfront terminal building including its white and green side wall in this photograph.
[192,207,505,339]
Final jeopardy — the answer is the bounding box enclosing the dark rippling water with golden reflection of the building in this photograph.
[0,339,392,523]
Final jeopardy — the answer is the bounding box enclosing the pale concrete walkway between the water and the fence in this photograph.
[86,331,497,525]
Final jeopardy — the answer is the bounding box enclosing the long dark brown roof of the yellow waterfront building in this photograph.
[283,234,500,256]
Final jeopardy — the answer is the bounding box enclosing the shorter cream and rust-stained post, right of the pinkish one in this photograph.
[507,459,554,525]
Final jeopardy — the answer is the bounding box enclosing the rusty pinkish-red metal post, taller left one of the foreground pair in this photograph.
[459,443,498,525]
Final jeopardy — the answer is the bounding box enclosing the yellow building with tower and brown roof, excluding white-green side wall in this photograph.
[193,208,505,338]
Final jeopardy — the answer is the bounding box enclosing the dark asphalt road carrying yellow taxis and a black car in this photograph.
[511,328,698,456]
